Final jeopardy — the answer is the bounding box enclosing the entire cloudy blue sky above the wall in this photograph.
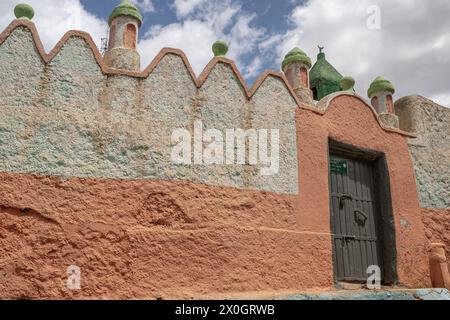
[0,0,450,107]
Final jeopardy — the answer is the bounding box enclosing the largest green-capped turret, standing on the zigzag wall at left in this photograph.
[104,0,142,71]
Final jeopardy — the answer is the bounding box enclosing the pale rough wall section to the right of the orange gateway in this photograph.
[395,96,450,208]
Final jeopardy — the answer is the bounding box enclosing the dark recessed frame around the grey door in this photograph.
[328,139,398,286]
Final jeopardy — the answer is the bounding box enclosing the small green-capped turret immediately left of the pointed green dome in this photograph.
[281,48,313,104]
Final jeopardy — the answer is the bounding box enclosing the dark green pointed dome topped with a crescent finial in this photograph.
[309,47,343,100]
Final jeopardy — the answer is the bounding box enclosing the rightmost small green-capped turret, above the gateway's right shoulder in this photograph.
[367,77,399,128]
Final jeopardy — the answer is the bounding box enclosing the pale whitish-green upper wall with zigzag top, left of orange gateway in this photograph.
[0,26,298,194]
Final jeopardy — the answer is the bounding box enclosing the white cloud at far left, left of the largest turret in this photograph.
[0,0,108,52]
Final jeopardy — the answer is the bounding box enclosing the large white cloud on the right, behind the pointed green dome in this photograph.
[278,0,450,106]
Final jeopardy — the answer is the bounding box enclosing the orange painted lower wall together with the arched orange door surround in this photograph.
[0,96,431,299]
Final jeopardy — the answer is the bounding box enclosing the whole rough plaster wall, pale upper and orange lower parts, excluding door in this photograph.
[0,21,430,299]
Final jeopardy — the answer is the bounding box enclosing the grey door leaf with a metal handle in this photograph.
[330,155,381,282]
